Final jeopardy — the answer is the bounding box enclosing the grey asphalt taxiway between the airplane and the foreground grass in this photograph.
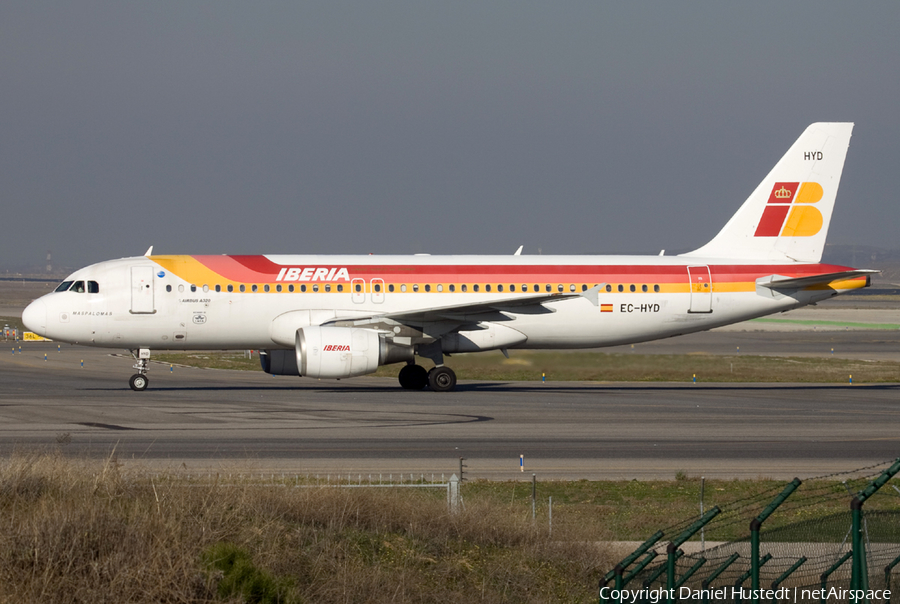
[0,343,900,479]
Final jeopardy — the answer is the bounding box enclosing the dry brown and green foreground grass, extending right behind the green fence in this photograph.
[0,453,900,604]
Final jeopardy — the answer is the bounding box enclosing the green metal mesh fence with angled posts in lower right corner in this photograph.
[600,458,900,604]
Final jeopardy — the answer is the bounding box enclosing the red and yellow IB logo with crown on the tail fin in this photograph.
[754,182,823,237]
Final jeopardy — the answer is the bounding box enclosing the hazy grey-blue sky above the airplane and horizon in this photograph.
[0,0,900,267]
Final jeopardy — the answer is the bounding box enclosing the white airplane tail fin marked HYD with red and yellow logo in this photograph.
[682,122,853,262]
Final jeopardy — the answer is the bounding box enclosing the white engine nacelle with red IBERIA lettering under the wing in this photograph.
[295,326,413,378]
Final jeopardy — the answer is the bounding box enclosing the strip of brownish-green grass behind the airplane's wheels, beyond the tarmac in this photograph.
[154,351,900,383]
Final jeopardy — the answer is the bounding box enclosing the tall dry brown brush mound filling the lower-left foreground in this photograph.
[0,455,612,604]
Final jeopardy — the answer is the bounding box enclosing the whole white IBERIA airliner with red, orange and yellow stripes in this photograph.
[22,123,877,391]
